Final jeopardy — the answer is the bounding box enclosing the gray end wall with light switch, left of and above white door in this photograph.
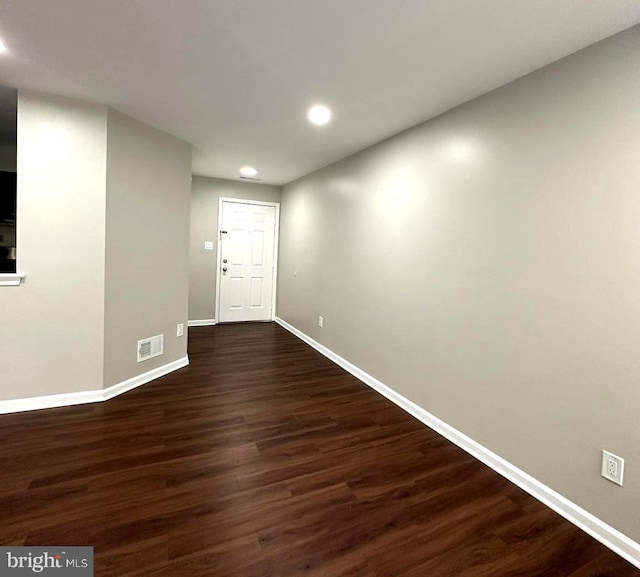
[189,176,280,320]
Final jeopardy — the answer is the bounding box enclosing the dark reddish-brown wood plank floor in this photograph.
[0,323,640,577]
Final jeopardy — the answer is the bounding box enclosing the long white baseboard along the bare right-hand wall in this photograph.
[276,318,640,568]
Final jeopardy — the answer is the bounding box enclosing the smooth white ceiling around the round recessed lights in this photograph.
[0,0,640,184]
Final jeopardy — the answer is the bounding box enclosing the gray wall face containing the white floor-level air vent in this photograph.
[104,110,191,388]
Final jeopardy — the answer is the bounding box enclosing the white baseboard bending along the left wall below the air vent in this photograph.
[0,355,189,414]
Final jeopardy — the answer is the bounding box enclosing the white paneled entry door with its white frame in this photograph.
[218,200,276,322]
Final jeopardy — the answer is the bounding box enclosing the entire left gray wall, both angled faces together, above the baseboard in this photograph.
[0,92,191,400]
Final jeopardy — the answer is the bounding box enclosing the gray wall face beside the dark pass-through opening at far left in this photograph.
[0,92,107,400]
